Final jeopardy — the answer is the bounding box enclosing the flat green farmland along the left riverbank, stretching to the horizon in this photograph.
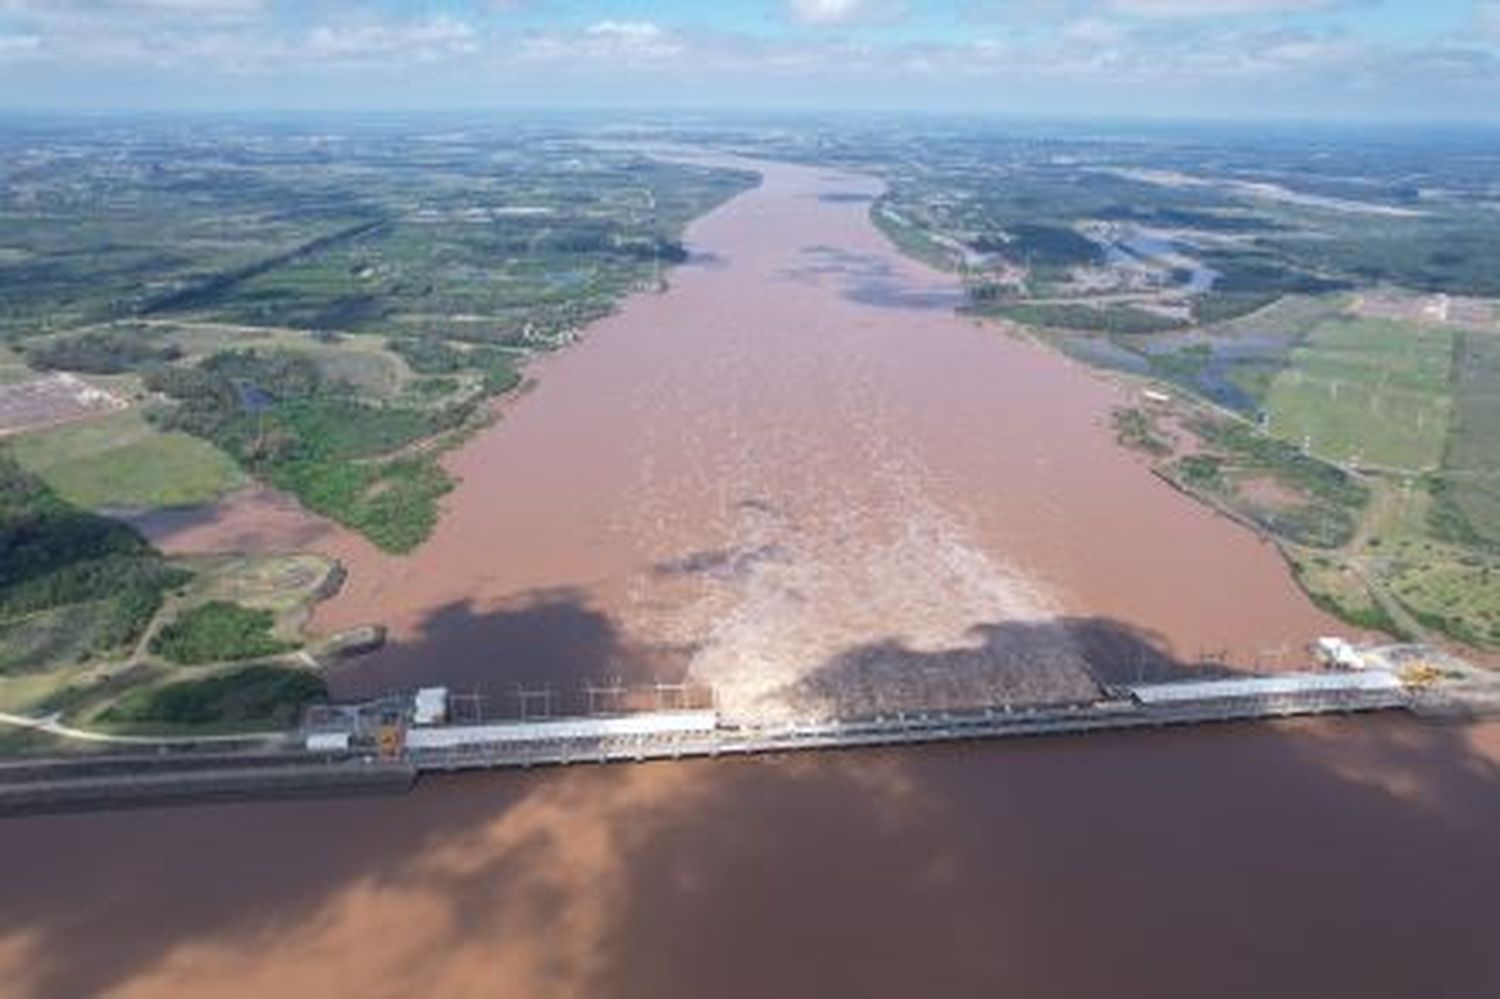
[0,120,752,552]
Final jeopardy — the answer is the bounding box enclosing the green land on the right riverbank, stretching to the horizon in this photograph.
[792,126,1500,648]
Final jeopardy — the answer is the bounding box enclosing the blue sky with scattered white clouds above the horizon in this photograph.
[0,0,1500,120]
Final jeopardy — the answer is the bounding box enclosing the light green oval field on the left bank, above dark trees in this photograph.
[12,411,246,510]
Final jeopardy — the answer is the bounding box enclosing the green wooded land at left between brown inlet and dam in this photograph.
[0,455,333,735]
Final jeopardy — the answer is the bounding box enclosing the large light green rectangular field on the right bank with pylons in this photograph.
[1266,318,1454,471]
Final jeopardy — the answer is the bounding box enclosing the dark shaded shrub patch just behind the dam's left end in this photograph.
[98,665,329,728]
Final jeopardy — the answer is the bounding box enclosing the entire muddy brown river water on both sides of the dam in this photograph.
[0,157,1500,998]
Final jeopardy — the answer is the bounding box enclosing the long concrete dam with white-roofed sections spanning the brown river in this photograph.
[0,672,1413,816]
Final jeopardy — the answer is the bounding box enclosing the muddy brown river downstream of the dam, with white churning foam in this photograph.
[135,156,1338,717]
